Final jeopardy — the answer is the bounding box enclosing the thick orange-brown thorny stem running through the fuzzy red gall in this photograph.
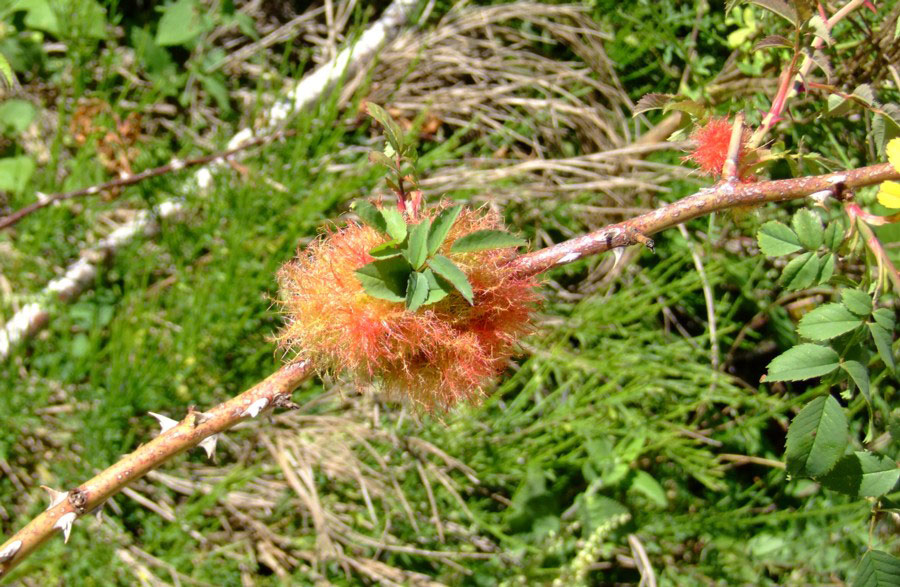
[0,163,900,577]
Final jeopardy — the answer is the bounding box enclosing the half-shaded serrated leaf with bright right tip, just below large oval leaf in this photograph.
[818,451,900,497]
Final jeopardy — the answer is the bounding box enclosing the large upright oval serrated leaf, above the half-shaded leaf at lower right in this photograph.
[784,395,847,477]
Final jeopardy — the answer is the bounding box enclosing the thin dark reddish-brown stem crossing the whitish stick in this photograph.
[0,129,297,230]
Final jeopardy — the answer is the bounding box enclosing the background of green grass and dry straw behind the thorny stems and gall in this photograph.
[0,0,900,585]
